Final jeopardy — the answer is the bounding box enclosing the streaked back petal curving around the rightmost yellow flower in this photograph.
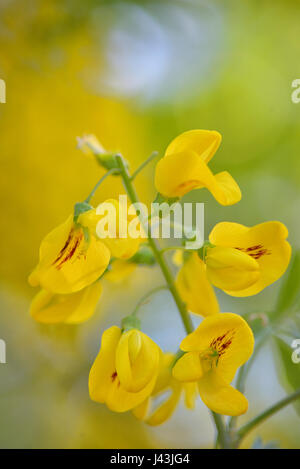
[209,221,291,297]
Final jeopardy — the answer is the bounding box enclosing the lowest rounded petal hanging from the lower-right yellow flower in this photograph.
[198,370,248,416]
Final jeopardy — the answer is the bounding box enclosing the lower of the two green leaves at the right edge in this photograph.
[274,336,300,415]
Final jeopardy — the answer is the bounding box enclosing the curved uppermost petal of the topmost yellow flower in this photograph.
[165,129,222,163]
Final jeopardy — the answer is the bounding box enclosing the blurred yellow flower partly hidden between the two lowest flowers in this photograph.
[132,353,197,426]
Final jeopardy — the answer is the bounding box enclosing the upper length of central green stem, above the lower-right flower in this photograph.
[116,155,194,334]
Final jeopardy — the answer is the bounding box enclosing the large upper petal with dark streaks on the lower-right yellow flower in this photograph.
[180,313,254,383]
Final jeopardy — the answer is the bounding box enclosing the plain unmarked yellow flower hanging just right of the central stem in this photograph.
[176,252,220,316]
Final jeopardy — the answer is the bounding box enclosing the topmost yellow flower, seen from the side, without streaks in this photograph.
[155,130,241,205]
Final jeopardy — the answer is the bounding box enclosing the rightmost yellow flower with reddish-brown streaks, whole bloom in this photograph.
[206,221,291,296]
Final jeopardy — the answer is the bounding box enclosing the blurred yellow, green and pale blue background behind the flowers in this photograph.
[0,0,300,448]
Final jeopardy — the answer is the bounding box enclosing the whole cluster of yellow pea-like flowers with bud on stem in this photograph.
[29,130,291,425]
